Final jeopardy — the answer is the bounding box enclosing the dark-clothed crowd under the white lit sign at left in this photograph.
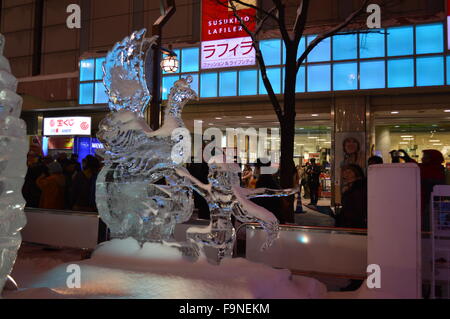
[22,152,101,212]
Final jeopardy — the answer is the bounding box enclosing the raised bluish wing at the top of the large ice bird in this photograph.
[103,29,157,116]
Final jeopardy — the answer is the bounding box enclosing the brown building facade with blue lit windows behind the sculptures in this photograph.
[1,0,450,203]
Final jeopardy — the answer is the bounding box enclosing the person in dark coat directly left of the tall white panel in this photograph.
[336,164,367,228]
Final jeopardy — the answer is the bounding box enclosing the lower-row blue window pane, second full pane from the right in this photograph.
[388,59,414,88]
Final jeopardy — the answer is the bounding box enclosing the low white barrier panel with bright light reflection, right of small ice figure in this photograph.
[246,226,367,277]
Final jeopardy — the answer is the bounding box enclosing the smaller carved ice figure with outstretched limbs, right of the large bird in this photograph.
[177,155,298,263]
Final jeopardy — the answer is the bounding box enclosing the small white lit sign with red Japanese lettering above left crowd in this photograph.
[44,116,91,136]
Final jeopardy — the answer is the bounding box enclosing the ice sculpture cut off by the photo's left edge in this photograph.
[0,35,28,293]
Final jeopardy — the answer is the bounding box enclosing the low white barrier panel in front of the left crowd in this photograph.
[21,210,99,249]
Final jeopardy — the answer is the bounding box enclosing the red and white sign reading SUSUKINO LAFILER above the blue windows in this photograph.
[201,0,257,69]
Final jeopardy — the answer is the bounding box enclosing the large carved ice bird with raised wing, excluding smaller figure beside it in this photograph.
[96,30,197,243]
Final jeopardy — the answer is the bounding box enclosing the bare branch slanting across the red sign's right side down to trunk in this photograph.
[230,2,283,123]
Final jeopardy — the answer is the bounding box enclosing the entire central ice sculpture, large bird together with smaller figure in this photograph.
[96,29,298,262]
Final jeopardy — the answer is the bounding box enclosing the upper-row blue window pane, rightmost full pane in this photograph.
[416,23,444,54]
